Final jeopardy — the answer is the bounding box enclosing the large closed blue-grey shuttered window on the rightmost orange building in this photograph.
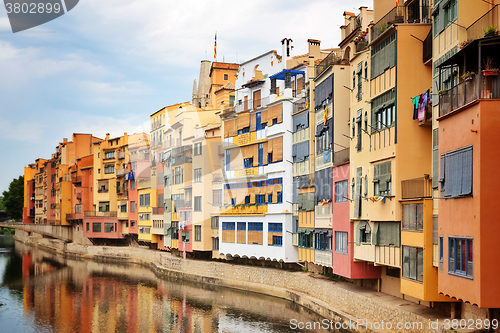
[439,147,472,197]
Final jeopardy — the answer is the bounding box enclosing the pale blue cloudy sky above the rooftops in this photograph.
[0,0,372,195]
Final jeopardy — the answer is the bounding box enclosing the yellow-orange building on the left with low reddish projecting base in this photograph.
[83,133,130,244]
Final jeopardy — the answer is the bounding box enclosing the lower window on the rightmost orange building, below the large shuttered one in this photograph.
[448,237,473,278]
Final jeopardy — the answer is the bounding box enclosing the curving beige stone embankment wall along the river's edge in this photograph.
[15,230,452,332]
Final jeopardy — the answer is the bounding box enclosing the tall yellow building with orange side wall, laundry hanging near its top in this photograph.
[350,0,449,305]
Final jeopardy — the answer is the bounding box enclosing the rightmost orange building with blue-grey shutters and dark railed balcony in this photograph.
[432,0,500,320]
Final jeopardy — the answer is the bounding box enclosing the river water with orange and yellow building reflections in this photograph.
[0,235,340,333]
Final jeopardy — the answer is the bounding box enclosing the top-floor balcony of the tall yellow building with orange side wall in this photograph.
[371,5,431,42]
